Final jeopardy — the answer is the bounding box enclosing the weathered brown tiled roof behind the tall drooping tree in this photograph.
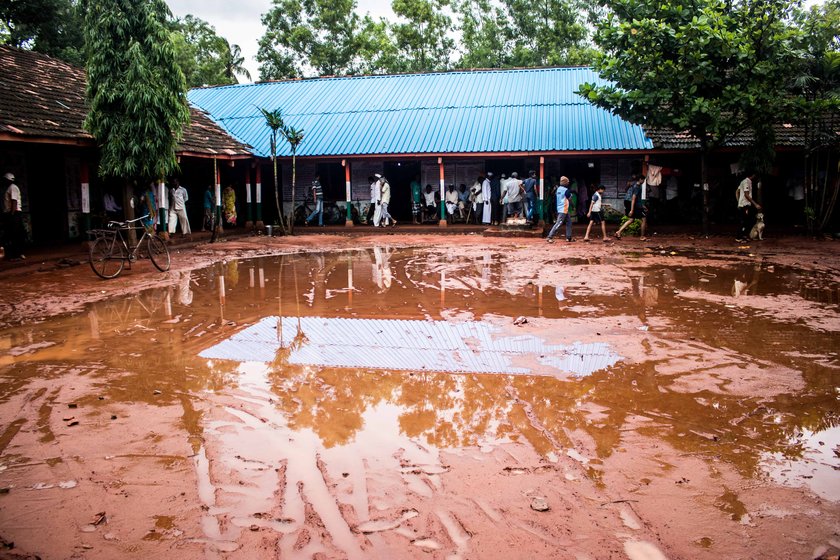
[0,46,251,157]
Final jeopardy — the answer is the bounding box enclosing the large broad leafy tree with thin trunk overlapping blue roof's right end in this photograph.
[580,0,797,233]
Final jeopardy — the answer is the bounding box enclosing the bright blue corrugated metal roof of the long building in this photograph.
[189,68,653,157]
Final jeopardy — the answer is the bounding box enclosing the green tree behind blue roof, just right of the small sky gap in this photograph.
[389,0,455,72]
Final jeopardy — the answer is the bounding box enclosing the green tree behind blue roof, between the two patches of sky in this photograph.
[257,0,361,80]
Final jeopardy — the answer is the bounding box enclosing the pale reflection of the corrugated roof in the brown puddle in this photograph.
[200,317,620,375]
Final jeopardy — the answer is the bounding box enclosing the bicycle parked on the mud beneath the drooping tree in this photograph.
[88,215,170,280]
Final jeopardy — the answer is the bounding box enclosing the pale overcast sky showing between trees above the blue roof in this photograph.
[167,0,394,80]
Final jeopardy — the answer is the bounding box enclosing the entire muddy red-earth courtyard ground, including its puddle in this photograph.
[0,234,840,560]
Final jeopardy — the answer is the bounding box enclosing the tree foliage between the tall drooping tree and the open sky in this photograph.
[170,15,251,87]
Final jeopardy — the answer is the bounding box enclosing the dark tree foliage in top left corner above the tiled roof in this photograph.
[0,0,84,65]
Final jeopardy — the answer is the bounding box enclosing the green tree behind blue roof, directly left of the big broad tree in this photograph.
[502,0,594,67]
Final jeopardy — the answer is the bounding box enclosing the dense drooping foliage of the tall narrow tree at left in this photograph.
[84,0,189,181]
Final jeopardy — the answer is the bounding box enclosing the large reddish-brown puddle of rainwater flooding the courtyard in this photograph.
[0,248,840,558]
